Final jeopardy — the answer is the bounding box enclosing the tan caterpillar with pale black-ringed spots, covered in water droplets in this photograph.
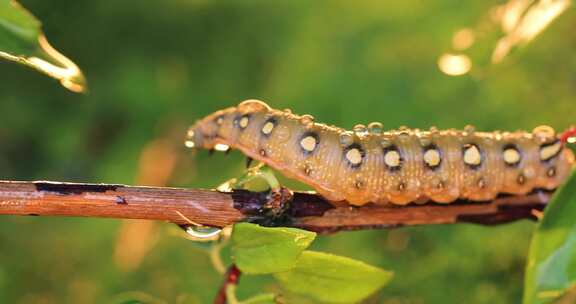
[188,100,574,205]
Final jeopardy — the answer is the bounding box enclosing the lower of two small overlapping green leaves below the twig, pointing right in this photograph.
[274,251,393,303]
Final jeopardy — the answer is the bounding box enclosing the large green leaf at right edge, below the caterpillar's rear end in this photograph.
[524,171,576,304]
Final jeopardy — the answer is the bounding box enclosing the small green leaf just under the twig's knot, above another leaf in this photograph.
[232,223,316,274]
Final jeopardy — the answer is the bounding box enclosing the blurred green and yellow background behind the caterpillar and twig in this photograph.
[0,0,576,304]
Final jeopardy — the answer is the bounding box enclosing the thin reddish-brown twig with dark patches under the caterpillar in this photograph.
[0,181,551,232]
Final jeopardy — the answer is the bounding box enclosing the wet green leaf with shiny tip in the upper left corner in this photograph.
[0,0,86,92]
